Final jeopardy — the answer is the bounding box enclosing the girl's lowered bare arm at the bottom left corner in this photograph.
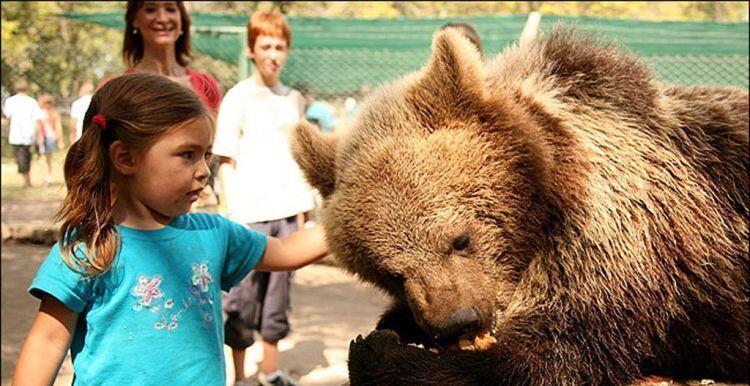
[12,295,78,386]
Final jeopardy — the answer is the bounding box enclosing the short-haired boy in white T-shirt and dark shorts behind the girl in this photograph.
[213,12,314,385]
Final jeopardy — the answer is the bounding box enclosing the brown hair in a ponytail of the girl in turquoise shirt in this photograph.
[57,73,211,275]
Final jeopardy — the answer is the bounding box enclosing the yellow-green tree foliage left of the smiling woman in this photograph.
[2,1,124,98]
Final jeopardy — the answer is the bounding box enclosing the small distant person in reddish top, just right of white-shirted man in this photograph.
[36,94,65,185]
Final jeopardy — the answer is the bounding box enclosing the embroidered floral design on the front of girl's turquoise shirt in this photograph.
[130,262,214,331]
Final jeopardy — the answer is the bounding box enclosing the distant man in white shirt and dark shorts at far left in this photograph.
[3,80,42,187]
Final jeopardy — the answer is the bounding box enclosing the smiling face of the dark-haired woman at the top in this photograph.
[133,1,182,47]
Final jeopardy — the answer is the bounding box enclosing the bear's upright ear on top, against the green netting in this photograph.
[406,28,485,126]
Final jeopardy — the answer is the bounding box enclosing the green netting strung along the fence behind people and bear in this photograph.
[62,13,748,97]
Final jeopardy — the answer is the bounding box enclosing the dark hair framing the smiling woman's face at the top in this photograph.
[122,0,192,67]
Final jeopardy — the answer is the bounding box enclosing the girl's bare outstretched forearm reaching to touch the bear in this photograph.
[255,225,328,271]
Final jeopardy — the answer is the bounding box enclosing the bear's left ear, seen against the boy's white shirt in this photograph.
[291,121,337,198]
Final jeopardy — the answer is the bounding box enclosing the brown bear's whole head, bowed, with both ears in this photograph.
[292,30,560,343]
